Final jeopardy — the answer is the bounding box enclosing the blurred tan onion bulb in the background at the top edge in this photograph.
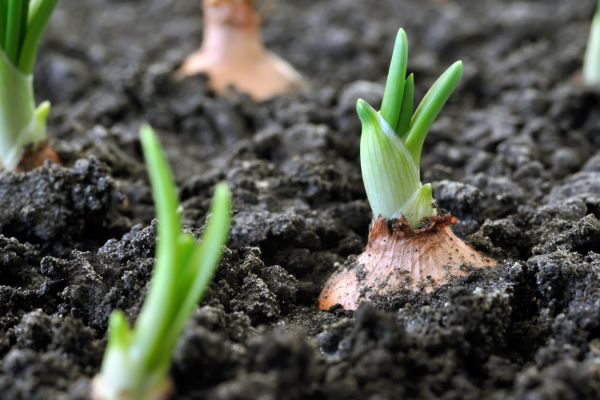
[177,0,305,101]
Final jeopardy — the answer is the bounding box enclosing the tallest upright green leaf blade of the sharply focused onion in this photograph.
[381,29,408,130]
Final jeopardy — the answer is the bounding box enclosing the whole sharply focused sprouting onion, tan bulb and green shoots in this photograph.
[320,29,493,309]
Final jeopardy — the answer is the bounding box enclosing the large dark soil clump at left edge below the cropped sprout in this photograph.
[0,157,128,257]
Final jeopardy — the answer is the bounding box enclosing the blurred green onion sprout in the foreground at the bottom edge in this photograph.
[92,126,231,400]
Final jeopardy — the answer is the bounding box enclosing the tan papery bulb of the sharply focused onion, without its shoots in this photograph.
[319,214,496,310]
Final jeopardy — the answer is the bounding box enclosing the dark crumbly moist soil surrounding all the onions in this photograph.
[0,0,600,400]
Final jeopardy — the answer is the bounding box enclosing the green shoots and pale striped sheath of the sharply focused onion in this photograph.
[356,29,463,229]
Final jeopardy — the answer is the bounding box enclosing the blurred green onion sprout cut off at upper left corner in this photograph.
[0,0,60,170]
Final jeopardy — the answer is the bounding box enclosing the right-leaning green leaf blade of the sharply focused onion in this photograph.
[404,61,463,165]
